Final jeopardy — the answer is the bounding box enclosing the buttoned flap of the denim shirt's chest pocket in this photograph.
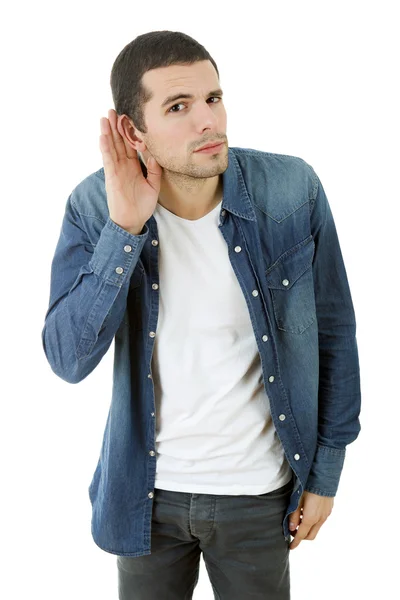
[265,238,315,290]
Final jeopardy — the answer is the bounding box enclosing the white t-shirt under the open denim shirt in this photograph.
[152,201,292,495]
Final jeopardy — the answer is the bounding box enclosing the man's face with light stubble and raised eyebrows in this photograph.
[136,60,228,178]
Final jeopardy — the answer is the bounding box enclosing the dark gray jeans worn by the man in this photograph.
[117,478,293,600]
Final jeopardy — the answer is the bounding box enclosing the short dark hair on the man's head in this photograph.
[110,30,219,133]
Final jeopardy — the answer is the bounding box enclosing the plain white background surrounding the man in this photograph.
[0,0,400,600]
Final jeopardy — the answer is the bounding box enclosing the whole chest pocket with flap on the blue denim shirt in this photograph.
[265,237,316,333]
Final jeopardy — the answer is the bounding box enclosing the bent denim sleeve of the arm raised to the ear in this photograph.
[42,192,149,383]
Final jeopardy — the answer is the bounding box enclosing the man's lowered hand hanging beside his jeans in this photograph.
[289,492,334,550]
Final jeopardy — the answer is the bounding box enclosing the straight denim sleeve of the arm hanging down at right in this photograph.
[305,172,361,496]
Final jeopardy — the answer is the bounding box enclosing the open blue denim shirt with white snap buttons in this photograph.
[42,147,361,556]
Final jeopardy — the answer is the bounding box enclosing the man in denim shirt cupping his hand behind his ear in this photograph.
[42,31,361,600]
